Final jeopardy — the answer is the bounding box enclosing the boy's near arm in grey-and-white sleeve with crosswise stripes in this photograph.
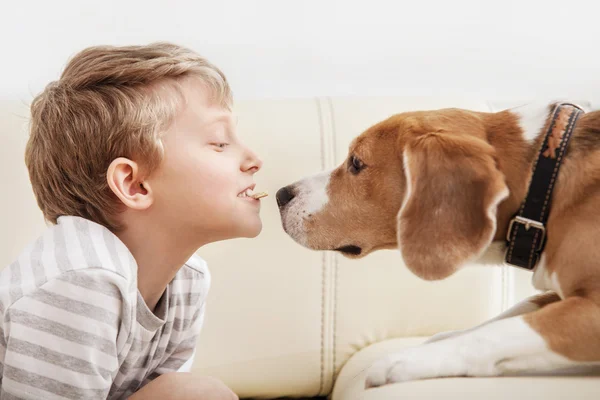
[0,269,129,399]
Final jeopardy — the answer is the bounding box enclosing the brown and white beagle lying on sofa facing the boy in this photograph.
[276,103,600,388]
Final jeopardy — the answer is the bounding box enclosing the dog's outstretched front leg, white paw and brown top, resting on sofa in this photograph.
[366,297,600,387]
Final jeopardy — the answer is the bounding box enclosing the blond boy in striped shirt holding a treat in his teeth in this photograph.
[0,43,262,399]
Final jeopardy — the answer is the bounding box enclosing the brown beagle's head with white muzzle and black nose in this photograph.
[277,109,508,279]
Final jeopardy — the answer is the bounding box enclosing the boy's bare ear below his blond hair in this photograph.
[106,157,154,211]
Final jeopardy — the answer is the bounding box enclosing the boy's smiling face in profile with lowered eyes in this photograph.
[148,79,262,242]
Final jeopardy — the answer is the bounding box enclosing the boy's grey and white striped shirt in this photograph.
[0,217,210,400]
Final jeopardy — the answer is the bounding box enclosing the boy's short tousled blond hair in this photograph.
[25,43,232,230]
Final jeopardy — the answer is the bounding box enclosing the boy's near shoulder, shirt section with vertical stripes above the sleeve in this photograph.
[0,216,137,309]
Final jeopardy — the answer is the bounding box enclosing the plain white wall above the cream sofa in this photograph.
[0,0,600,101]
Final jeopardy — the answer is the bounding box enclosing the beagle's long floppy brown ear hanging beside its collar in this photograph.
[398,133,508,280]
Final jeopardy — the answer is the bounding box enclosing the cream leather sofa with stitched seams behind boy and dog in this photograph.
[0,97,600,400]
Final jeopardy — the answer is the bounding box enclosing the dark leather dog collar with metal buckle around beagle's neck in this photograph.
[505,103,584,270]
